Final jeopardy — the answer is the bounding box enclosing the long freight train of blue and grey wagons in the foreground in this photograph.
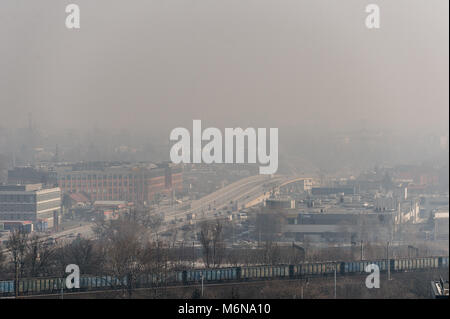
[0,256,449,297]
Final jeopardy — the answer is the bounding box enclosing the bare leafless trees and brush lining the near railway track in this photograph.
[0,209,446,297]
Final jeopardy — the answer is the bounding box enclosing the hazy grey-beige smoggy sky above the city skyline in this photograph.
[0,0,449,136]
